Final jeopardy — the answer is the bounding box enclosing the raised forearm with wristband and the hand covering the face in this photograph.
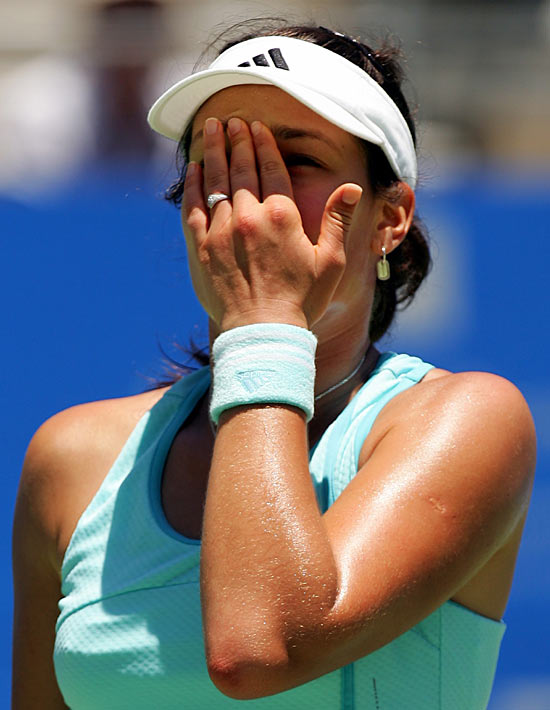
[187,111,362,697]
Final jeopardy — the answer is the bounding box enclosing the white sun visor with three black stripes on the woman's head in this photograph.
[147,36,417,188]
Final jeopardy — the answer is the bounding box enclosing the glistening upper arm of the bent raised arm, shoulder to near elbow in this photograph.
[325,373,535,655]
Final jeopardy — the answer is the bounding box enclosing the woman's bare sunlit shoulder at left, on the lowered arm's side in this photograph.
[14,388,170,567]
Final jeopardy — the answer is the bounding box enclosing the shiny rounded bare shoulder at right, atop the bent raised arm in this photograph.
[377,369,536,512]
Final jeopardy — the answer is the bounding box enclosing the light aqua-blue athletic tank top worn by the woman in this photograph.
[54,353,505,710]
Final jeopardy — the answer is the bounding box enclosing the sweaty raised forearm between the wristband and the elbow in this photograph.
[201,406,337,663]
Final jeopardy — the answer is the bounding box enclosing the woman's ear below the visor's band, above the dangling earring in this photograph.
[372,182,415,255]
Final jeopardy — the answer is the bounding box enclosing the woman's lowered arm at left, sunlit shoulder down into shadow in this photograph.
[13,388,166,710]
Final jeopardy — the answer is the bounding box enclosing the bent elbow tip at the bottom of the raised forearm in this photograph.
[206,642,289,700]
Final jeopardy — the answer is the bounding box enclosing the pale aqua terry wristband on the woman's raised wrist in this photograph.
[210,323,317,424]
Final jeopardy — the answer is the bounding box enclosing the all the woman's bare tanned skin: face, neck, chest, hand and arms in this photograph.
[13,86,535,710]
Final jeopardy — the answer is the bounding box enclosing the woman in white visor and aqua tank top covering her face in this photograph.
[14,22,534,710]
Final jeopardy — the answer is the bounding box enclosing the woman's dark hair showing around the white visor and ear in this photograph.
[166,21,431,350]
